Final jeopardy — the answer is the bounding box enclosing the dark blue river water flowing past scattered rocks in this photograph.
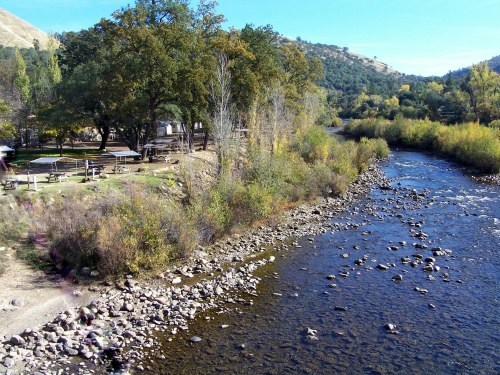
[138,152,500,374]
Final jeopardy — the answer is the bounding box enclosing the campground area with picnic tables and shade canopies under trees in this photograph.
[0,142,215,196]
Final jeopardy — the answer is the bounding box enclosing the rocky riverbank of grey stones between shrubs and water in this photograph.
[0,165,389,374]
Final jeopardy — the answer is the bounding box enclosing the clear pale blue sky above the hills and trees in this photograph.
[0,0,500,76]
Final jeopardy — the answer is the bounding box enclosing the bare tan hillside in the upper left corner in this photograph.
[0,9,49,49]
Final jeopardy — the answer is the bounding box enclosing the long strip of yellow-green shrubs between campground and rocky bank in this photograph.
[2,127,389,276]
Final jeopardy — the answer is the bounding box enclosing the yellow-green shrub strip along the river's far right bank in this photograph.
[345,117,500,173]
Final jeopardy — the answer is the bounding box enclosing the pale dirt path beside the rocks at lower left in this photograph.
[0,248,94,338]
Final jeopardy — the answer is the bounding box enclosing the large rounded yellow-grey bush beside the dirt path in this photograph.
[32,186,198,275]
